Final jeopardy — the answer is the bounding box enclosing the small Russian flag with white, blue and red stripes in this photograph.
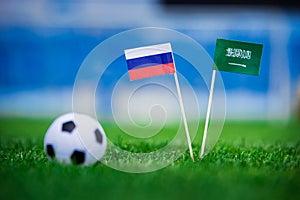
[125,43,175,81]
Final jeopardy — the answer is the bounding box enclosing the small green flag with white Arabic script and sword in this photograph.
[213,39,263,76]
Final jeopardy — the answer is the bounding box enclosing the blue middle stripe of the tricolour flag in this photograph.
[126,52,173,70]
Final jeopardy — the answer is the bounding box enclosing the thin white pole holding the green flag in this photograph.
[200,69,217,158]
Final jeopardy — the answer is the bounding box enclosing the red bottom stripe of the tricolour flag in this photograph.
[128,63,175,81]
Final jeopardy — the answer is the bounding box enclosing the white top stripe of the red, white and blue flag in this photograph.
[125,43,172,60]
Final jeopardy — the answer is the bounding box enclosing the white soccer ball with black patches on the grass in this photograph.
[44,113,107,165]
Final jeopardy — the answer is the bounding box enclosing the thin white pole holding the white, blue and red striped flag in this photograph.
[174,71,195,162]
